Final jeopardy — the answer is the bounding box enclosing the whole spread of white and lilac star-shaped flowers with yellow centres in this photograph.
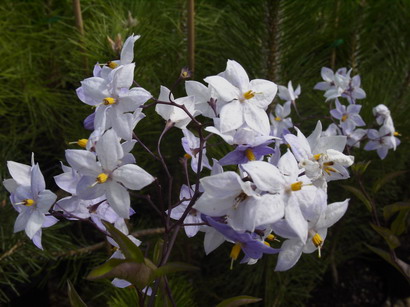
[4,35,399,286]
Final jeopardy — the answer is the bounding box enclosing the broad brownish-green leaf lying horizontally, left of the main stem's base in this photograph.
[87,259,154,289]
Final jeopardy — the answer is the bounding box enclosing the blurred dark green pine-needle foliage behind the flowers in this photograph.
[0,0,410,306]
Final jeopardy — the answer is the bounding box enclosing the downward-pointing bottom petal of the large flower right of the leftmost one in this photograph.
[106,181,130,219]
